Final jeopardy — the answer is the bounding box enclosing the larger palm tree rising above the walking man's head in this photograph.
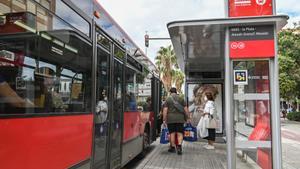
[155,45,178,91]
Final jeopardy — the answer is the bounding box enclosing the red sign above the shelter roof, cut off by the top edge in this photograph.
[228,0,273,17]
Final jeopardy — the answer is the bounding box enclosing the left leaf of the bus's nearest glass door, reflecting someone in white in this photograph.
[93,37,111,169]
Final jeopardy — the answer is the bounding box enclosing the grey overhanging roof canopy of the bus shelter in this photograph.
[167,15,289,79]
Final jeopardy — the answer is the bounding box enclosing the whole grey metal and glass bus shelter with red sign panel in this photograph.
[167,15,288,169]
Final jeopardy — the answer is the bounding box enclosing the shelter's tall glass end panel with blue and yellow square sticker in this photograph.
[233,60,272,169]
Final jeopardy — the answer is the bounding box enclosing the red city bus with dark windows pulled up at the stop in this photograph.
[0,0,161,169]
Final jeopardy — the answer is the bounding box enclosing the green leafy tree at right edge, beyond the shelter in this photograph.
[278,27,300,100]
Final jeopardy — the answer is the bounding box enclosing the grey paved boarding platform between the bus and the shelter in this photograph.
[135,141,259,169]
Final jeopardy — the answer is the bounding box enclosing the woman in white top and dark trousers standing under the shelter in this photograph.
[202,93,217,150]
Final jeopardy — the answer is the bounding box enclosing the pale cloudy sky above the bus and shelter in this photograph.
[98,0,300,63]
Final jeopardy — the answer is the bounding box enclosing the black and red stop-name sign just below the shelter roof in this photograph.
[229,25,275,59]
